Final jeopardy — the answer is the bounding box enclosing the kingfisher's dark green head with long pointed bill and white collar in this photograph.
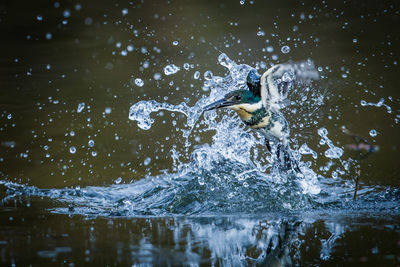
[204,89,261,111]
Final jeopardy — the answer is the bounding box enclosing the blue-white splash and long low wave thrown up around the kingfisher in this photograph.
[3,54,388,219]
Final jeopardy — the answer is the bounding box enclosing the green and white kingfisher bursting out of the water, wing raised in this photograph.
[204,62,318,172]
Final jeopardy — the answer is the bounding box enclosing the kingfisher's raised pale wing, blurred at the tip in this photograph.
[261,61,319,109]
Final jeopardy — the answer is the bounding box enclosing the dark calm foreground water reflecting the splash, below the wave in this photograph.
[0,198,400,266]
